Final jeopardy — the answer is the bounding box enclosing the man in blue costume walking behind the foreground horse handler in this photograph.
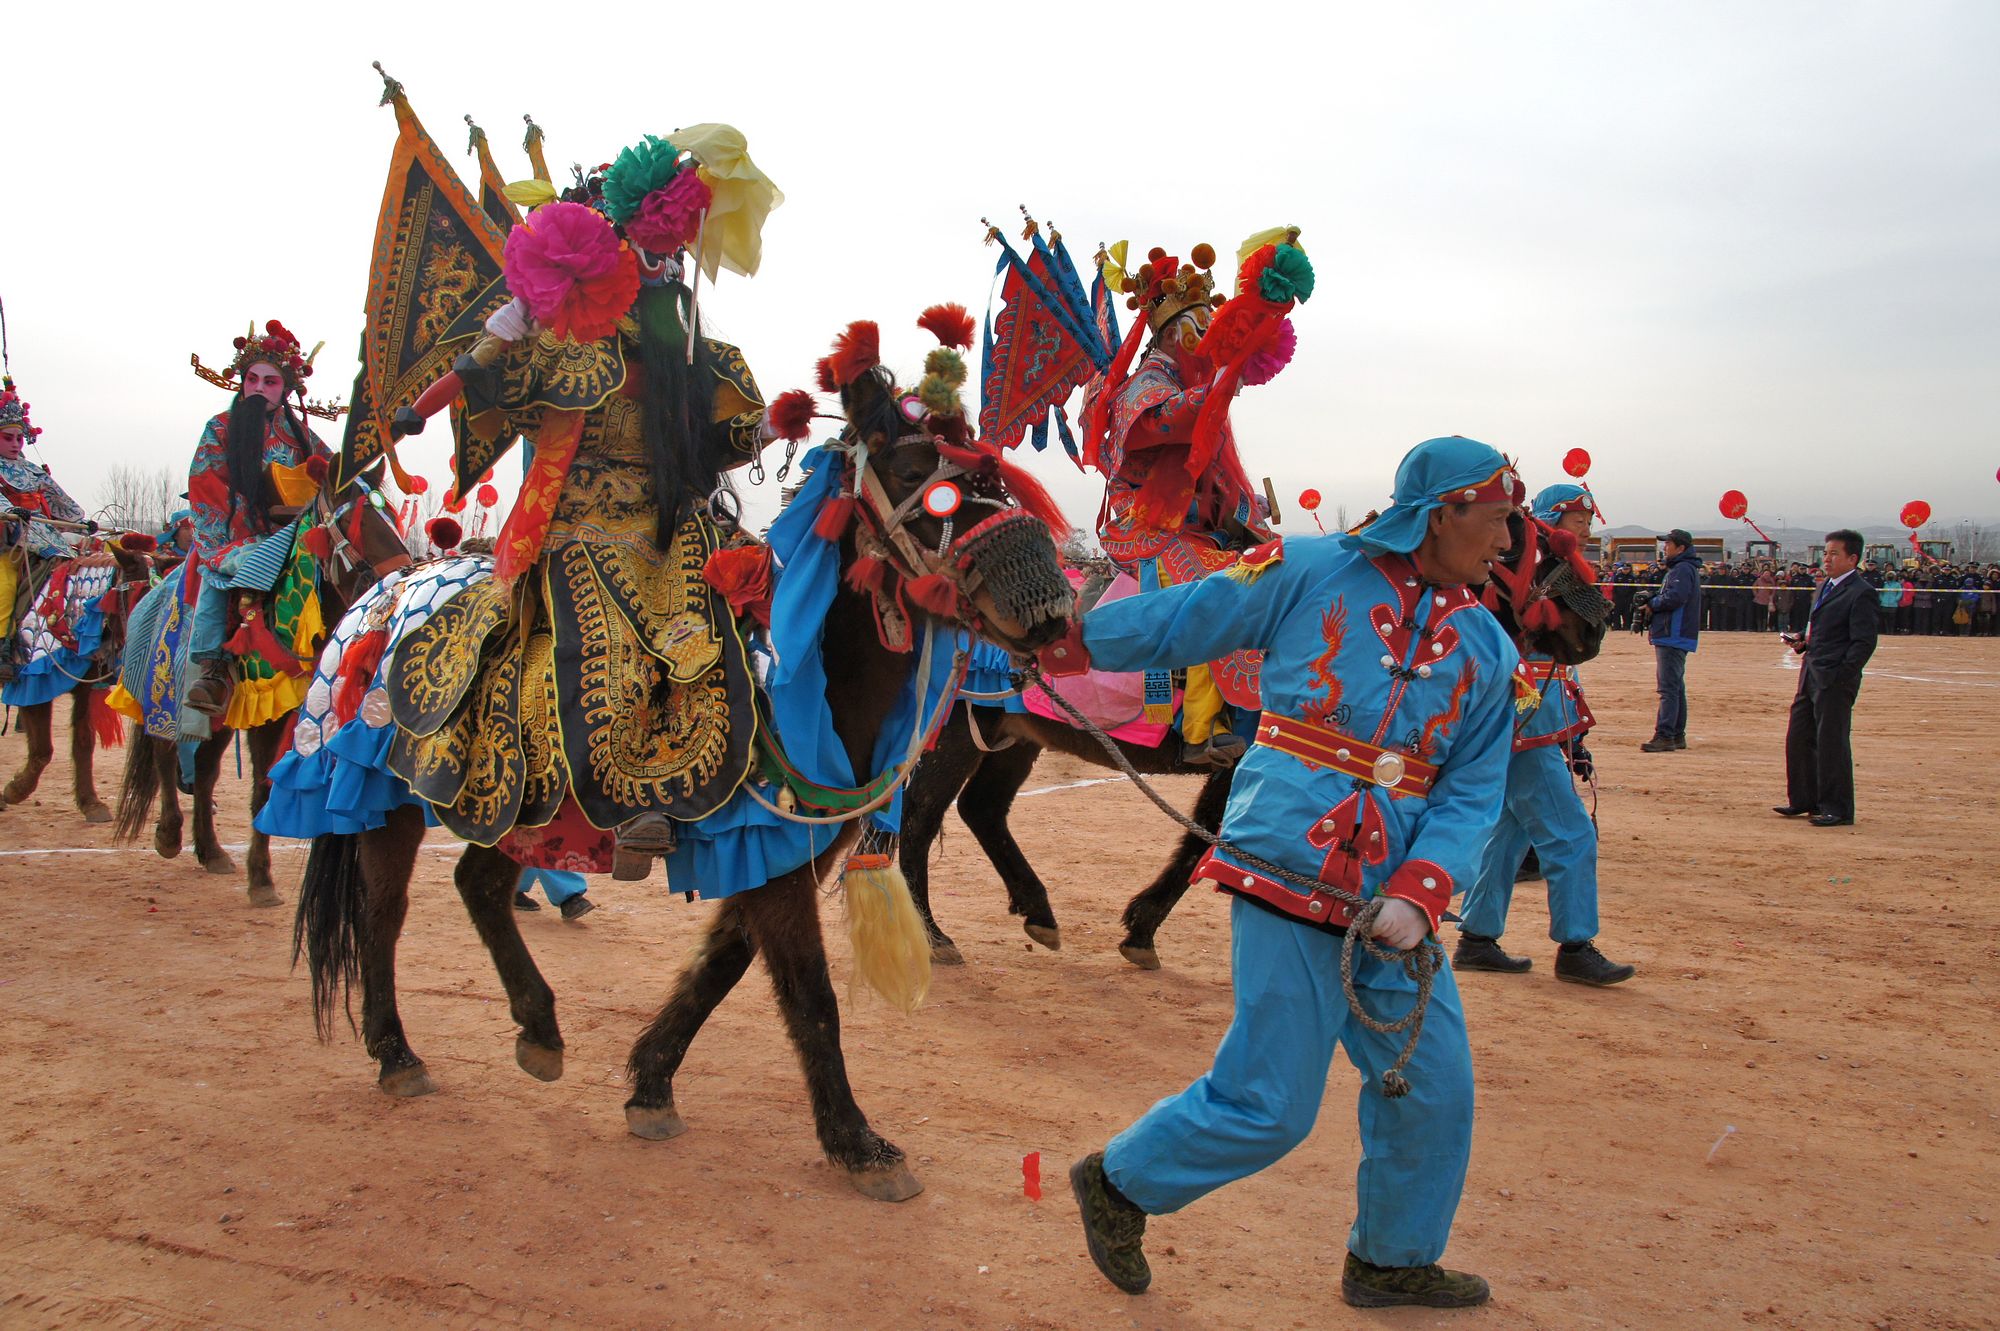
[1452,484,1634,985]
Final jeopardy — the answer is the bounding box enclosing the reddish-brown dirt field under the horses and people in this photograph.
[0,636,2000,1331]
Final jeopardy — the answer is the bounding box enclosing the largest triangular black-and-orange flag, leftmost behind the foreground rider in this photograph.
[336,66,508,486]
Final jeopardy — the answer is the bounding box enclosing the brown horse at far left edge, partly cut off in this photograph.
[0,536,152,823]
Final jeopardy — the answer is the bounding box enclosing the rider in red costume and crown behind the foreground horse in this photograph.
[1082,228,1312,765]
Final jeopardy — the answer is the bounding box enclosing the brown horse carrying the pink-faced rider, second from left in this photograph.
[112,471,410,905]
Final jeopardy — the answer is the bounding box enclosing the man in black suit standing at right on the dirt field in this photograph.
[1778,532,1880,827]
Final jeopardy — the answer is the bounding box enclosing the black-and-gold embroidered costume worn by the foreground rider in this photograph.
[386,318,766,845]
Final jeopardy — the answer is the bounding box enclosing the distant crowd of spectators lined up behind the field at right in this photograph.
[1598,560,2000,638]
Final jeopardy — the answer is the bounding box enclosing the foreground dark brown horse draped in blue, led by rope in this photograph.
[294,347,1068,1201]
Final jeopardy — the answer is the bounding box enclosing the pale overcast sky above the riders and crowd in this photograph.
[0,0,2000,534]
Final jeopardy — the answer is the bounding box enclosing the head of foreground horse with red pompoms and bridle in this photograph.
[820,315,1074,656]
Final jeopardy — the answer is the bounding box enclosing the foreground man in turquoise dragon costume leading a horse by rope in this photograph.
[1040,438,1522,1307]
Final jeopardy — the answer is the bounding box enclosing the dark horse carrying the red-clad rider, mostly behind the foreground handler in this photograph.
[898,505,1610,971]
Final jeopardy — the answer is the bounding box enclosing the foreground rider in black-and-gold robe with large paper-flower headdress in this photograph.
[388,124,784,877]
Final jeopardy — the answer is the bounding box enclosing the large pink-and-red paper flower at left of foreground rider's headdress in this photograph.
[502,204,638,342]
